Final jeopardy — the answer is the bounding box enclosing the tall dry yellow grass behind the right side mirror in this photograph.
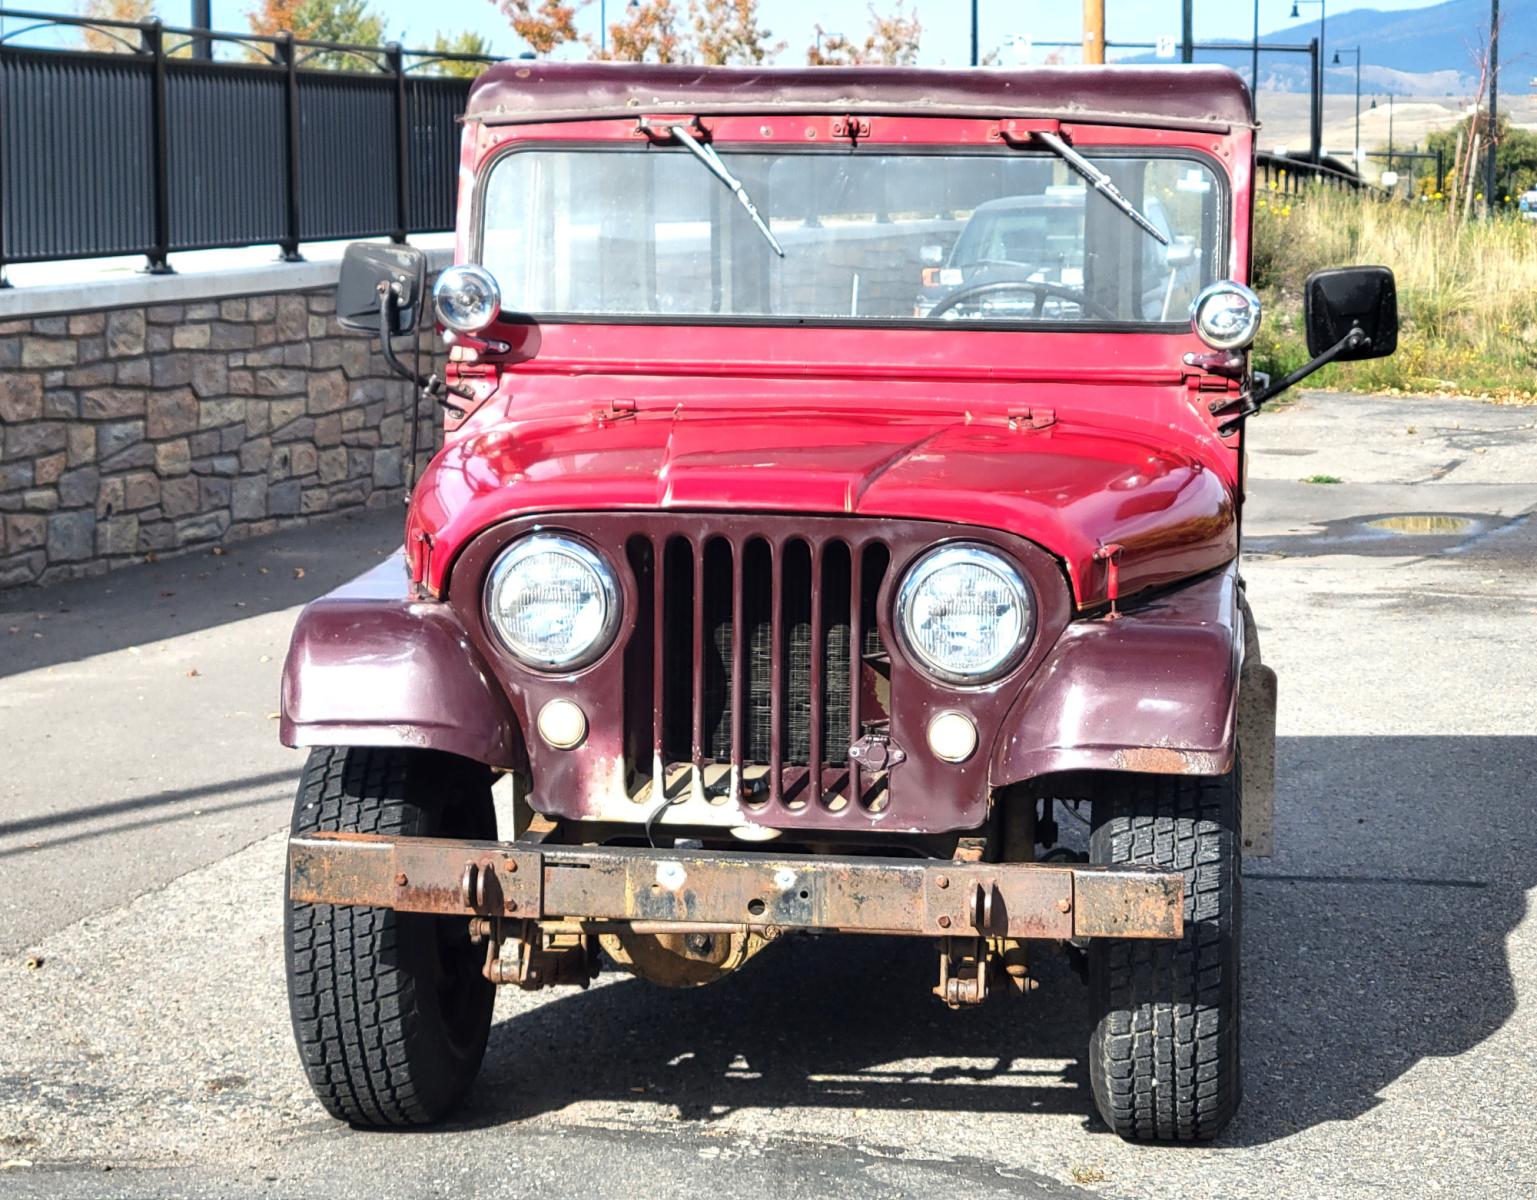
[1254,189,1537,398]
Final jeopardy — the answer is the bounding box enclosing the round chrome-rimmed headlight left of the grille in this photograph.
[486,533,619,670]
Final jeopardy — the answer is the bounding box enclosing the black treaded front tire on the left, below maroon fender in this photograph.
[284,748,496,1126]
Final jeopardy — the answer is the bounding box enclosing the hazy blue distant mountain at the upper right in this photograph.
[1133,0,1537,95]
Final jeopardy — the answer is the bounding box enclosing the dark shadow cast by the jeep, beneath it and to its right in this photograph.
[451,738,1537,1145]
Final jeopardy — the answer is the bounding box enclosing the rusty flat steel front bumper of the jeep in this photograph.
[289,833,1185,939]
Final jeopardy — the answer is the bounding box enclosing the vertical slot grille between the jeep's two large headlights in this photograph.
[626,535,890,808]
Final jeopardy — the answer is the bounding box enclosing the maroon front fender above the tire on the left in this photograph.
[278,553,527,770]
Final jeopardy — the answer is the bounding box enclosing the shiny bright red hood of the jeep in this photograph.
[407,409,1237,607]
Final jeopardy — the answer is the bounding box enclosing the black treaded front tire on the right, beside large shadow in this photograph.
[1088,771,1242,1142]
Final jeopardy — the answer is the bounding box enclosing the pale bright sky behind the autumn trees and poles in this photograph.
[6,0,1450,63]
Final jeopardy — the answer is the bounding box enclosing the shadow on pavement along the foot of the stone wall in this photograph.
[0,504,404,678]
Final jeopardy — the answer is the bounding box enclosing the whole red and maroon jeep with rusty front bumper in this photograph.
[281,61,1397,1140]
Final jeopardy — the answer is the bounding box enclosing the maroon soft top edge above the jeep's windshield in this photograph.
[464,60,1254,131]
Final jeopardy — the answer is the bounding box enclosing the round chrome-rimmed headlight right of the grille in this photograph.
[896,542,1036,684]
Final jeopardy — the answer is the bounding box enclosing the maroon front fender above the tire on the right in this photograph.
[991,562,1243,787]
